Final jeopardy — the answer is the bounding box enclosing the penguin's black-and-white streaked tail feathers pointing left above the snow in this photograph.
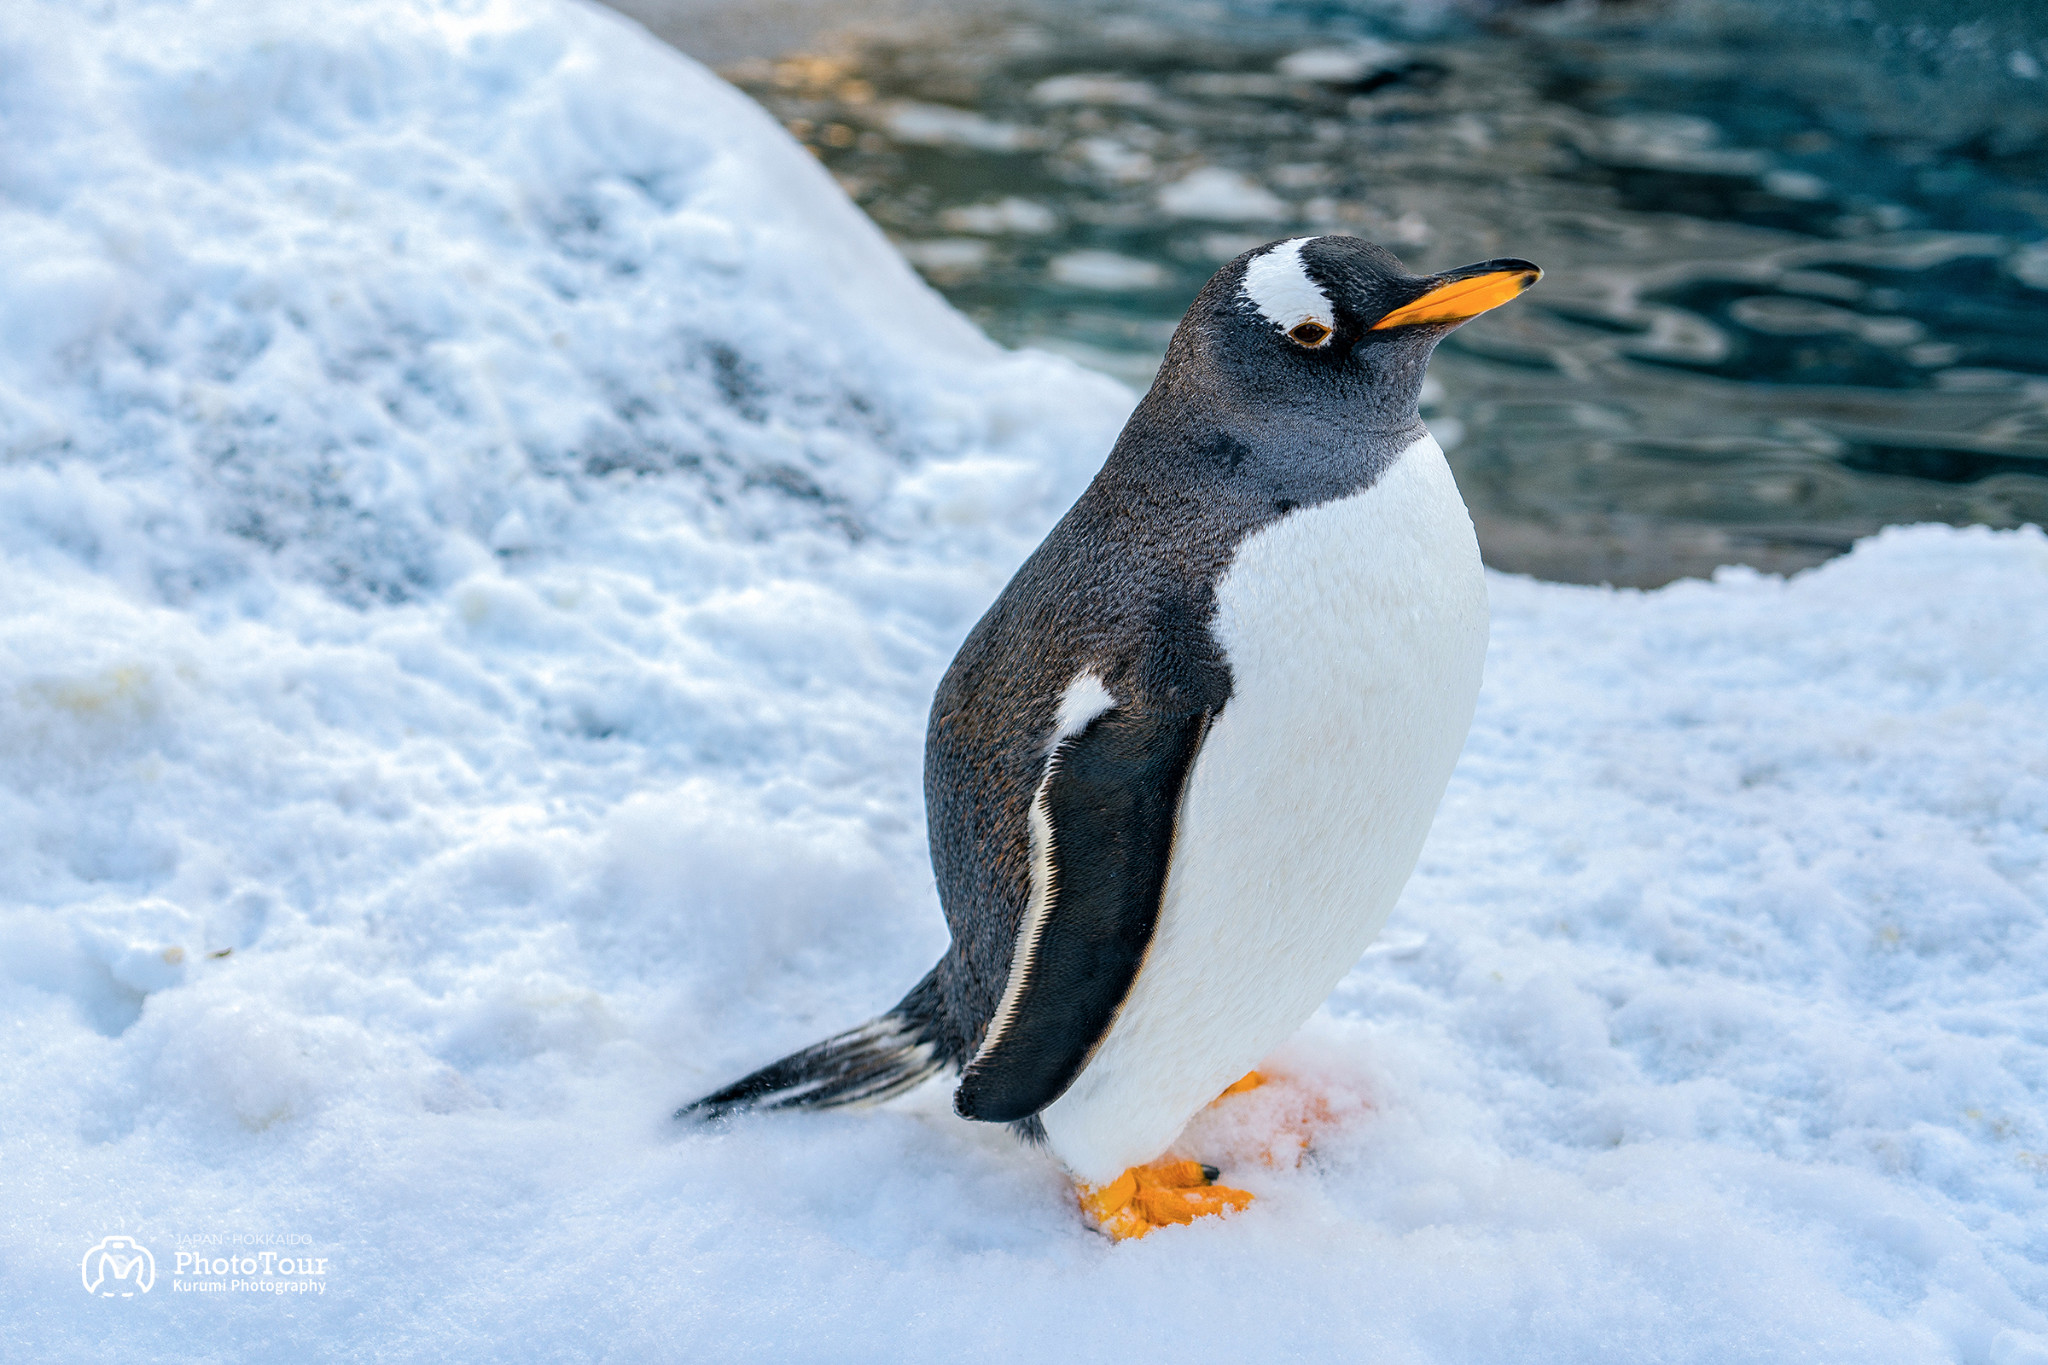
[676,968,952,1124]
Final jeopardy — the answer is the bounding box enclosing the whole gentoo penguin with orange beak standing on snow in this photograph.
[678,235,1542,1236]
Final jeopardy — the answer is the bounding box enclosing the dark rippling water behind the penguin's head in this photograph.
[729,2,2048,585]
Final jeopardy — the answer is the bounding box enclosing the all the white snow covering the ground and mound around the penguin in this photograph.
[0,0,2048,1365]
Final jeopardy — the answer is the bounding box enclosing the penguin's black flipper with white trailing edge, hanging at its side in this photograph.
[952,706,1212,1124]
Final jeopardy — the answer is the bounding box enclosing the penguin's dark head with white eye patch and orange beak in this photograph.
[1155,237,1542,430]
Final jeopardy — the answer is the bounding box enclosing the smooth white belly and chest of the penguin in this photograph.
[1040,436,1487,1183]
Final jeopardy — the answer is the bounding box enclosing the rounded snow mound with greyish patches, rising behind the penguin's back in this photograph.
[0,0,1120,604]
